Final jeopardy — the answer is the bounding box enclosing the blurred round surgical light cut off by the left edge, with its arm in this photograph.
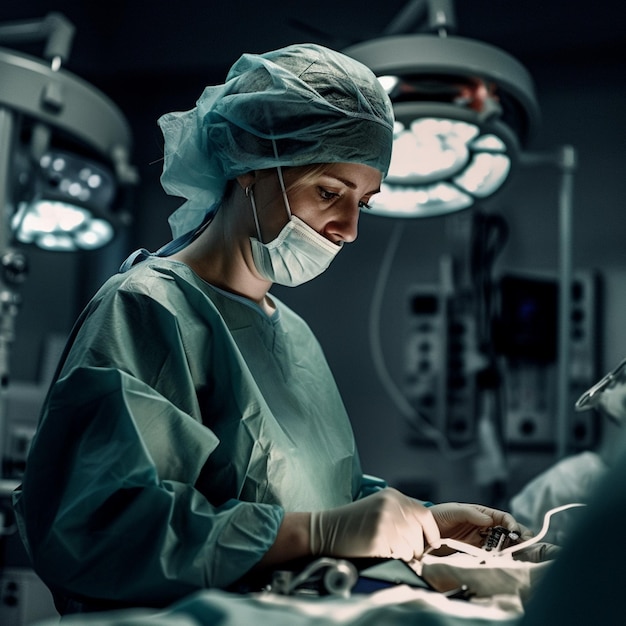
[0,13,137,251]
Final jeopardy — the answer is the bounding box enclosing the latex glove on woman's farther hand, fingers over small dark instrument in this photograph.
[430,502,532,547]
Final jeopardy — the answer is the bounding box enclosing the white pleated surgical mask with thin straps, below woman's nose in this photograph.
[246,167,341,287]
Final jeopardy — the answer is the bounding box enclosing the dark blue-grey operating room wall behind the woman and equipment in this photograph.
[6,58,626,500]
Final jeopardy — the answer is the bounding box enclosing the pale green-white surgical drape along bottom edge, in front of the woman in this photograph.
[31,585,523,626]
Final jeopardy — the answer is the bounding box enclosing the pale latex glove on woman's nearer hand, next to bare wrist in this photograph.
[311,487,440,561]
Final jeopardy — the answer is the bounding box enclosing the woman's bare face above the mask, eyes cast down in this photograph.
[244,163,382,243]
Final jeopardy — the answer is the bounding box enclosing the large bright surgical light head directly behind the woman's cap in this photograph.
[344,34,539,217]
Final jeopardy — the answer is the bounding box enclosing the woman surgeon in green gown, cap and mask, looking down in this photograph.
[14,44,518,613]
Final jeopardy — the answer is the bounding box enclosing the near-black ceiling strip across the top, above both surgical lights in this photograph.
[0,0,626,82]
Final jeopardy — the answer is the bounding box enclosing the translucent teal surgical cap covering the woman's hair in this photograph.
[158,44,393,237]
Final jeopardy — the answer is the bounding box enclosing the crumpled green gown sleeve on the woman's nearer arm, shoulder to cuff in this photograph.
[14,272,284,606]
